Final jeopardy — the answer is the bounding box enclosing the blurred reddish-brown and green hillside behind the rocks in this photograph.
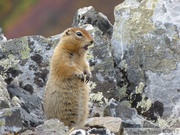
[0,0,123,39]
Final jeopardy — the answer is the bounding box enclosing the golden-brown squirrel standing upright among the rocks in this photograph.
[44,28,94,128]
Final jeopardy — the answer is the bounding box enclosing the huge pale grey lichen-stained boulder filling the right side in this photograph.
[111,0,180,127]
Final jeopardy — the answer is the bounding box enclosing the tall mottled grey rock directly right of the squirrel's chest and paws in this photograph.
[90,26,118,99]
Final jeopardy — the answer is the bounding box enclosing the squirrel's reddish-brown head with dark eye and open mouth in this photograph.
[62,28,94,50]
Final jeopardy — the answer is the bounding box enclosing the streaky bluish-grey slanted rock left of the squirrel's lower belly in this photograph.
[8,86,44,127]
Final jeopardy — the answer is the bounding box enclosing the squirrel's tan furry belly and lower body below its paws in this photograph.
[44,80,89,127]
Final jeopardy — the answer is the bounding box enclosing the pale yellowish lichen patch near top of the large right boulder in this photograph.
[119,3,154,43]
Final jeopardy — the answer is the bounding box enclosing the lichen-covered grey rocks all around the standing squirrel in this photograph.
[0,0,180,135]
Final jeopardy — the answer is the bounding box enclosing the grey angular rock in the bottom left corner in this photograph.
[0,107,43,133]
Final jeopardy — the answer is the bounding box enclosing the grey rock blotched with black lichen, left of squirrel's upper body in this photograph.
[0,36,54,97]
